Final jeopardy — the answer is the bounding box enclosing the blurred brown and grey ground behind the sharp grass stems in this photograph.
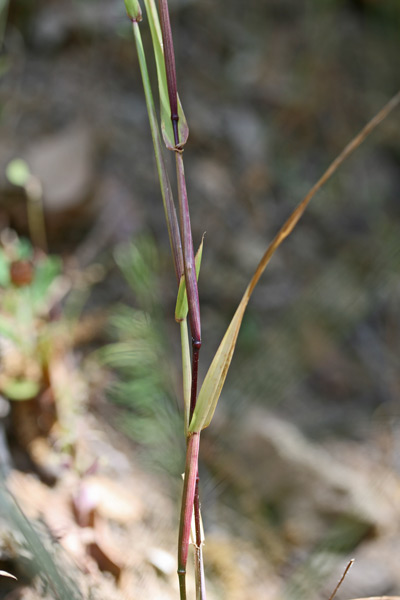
[0,0,400,600]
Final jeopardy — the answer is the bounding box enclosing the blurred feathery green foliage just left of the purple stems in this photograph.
[100,237,184,476]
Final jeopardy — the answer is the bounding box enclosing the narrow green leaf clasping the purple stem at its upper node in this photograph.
[144,0,189,150]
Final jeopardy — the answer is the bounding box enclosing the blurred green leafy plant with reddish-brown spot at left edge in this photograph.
[0,231,64,400]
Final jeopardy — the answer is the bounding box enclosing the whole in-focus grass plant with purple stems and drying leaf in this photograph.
[125,0,400,600]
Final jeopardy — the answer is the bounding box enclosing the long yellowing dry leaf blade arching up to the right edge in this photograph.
[189,92,400,433]
